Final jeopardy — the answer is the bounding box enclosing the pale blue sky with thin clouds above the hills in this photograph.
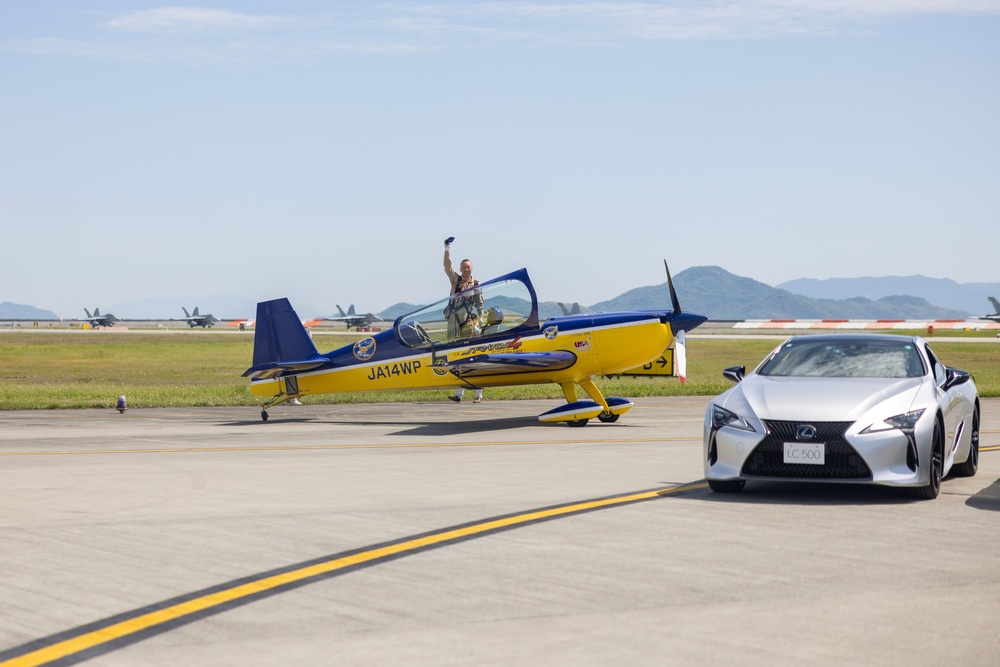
[0,0,1000,317]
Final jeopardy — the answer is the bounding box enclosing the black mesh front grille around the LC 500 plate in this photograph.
[741,420,872,479]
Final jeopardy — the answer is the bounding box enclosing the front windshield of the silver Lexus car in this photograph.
[757,339,924,378]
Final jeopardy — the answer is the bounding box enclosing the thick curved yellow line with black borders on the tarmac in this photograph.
[0,481,708,667]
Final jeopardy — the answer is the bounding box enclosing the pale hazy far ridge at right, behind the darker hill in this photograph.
[778,276,1000,316]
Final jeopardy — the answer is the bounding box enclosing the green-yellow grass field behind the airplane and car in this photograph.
[0,331,1000,410]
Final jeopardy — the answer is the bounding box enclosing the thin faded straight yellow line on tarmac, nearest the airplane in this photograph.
[0,437,701,457]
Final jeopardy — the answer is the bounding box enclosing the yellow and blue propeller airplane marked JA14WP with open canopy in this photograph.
[243,262,707,426]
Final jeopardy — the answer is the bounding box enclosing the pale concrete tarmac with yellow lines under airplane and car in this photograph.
[0,400,1000,667]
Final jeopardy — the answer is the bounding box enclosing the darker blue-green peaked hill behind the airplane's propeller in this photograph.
[590,266,965,320]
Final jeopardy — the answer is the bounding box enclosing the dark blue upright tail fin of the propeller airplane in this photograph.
[243,299,329,380]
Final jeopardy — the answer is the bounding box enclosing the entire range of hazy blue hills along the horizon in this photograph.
[0,266,1000,321]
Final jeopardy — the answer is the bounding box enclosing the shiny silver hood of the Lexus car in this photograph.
[739,375,923,421]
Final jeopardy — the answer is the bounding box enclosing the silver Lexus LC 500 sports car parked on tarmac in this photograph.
[704,334,979,499]
